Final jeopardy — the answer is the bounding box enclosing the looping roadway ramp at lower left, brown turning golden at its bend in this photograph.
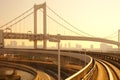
[0,61,48,80]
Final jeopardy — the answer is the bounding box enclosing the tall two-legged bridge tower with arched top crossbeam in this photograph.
[34,3,47,49]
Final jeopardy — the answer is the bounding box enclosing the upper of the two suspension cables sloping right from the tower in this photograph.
[47,6,94,37]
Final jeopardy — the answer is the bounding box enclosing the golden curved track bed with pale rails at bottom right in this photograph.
[95,59,120,80]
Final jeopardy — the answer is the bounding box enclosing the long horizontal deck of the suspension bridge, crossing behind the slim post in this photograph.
[3,32,120,46]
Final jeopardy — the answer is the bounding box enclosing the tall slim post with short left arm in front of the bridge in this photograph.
[49,34,61,80]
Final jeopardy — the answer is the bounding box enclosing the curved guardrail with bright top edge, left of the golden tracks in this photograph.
[65,57,96,80]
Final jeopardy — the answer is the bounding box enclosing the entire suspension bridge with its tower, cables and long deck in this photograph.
[0,3,120,49]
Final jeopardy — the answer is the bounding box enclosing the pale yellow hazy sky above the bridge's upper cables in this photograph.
[0,0,120,47]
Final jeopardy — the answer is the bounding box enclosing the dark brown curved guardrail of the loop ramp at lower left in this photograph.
[0,61,39,80]
